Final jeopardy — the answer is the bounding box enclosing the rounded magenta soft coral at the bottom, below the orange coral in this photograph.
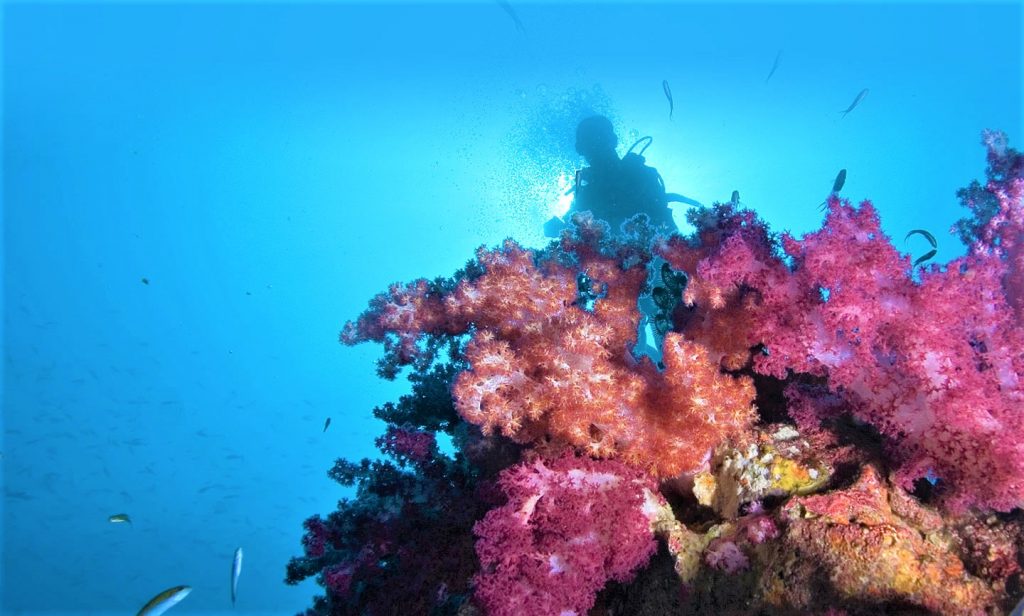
[473,455,656,616]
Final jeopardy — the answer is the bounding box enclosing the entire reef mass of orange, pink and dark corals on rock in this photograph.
[288,132,1024,616]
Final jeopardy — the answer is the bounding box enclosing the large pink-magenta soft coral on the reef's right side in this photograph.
[668,190,1024,511]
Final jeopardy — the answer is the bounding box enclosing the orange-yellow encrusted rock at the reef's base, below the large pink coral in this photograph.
[764,467,994,614]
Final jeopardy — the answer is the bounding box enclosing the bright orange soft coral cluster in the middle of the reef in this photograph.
[345,229,756,477]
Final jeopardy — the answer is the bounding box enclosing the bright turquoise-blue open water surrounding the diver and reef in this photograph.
[0,2,1024,614]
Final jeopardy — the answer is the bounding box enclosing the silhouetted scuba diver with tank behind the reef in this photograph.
[544,116,700,237]
